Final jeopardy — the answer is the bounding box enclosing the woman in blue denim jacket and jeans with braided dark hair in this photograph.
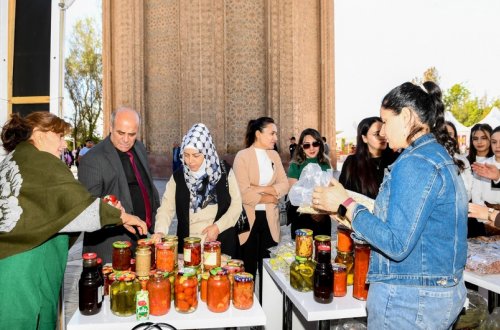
[313,82,467,329]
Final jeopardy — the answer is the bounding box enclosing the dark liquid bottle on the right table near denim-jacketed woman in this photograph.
[314,245,333,304]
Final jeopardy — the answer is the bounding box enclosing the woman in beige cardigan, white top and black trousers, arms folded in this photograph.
[233,117,288,297]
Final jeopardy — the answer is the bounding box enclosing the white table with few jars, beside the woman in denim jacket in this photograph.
[262,259,366,330]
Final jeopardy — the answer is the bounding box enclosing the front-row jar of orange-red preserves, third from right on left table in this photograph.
[174,268,198,313]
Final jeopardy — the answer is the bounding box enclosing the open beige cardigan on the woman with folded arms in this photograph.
[233,146,289,244]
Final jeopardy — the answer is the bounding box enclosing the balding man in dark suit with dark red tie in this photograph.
[78,108,160,263]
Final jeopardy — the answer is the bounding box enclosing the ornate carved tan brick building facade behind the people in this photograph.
[103,0,335,176]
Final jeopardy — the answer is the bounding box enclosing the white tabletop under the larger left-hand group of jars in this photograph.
[66,296,266,330]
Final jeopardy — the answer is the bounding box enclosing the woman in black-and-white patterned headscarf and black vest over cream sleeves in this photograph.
[153,123,242,257]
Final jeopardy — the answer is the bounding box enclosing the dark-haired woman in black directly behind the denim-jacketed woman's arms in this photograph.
[339,117,399,199]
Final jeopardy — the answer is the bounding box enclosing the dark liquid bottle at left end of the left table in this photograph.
[78,253,102,315]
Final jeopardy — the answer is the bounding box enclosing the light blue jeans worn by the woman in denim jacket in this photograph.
[366,279,467,330]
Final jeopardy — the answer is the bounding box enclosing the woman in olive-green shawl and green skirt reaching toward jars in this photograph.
[0,111,146,330]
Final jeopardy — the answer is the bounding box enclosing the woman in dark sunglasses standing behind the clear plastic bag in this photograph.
[287,128,332,239]
